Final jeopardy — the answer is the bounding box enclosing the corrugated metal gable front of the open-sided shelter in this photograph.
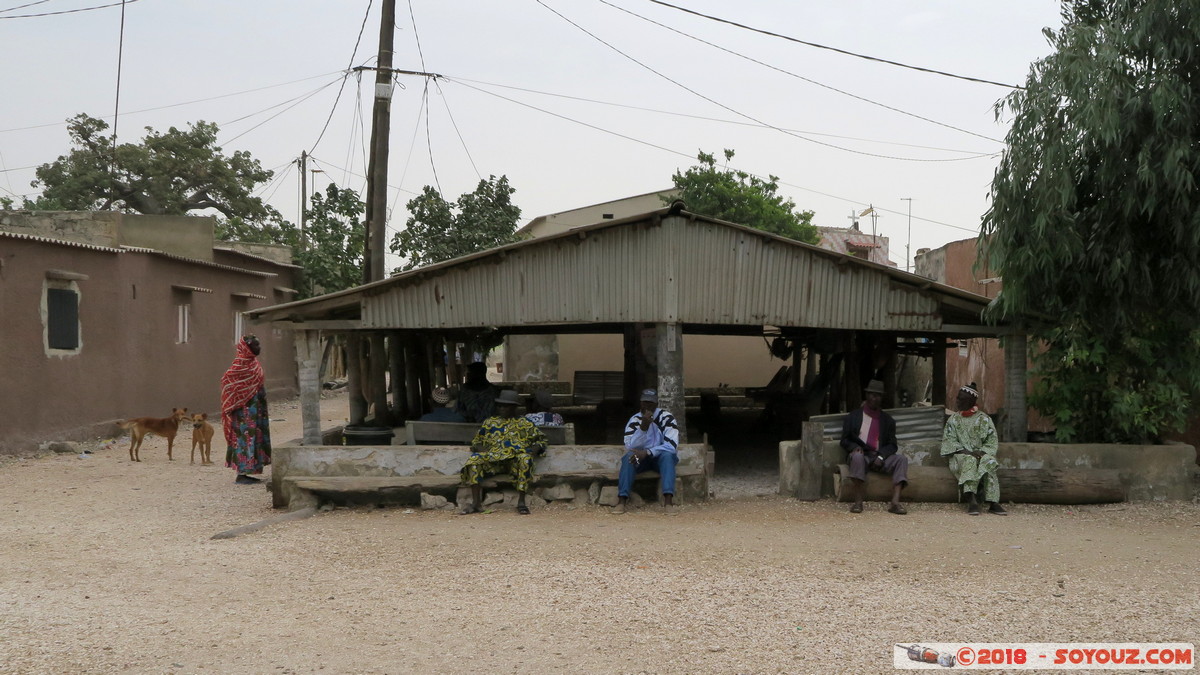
[250,204,989,333]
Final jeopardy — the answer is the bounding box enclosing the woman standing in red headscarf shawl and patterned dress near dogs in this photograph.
[221,335,271,484]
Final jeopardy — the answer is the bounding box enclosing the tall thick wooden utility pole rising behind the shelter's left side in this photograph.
[362,0,396,283]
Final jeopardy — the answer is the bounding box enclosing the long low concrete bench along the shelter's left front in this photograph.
[271,443,709,509]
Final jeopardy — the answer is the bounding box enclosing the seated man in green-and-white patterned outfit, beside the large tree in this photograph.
[942,382,1008,515]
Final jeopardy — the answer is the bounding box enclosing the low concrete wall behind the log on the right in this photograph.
[779,432,1196,501]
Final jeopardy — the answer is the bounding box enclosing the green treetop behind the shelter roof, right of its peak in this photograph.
[664,150,821,244]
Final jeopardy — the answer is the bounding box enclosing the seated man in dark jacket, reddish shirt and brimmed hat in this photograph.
[841,380,908,515]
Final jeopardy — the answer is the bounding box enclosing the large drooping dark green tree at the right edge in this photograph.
[980,0,1200,442]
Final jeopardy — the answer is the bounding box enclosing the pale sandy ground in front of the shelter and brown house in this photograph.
[0,398,1200,674]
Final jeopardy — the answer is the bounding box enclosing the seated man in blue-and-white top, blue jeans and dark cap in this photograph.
[613,389,679,513]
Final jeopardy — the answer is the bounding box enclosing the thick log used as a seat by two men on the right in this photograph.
[833,464,1126,504]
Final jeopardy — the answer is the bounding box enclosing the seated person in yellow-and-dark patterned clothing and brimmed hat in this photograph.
[458,389,546,515]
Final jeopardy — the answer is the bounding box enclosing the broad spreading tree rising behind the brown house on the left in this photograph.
[24,114,280,223]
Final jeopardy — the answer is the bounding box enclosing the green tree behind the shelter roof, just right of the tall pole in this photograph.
[391,175,521,269]
